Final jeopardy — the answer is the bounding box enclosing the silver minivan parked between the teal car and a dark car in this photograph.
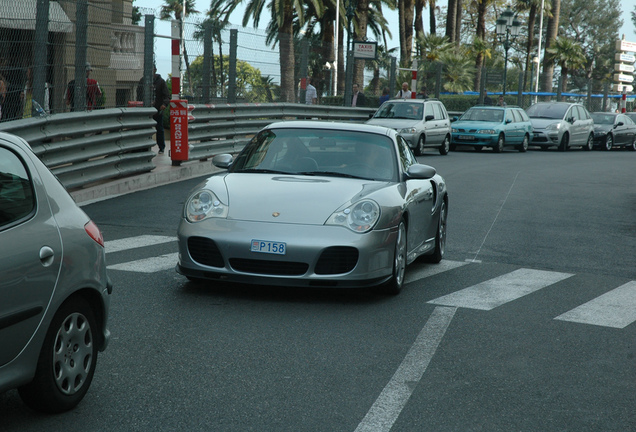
[526,102,594,151]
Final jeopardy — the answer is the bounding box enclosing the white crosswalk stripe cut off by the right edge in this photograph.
[555,281,636,328]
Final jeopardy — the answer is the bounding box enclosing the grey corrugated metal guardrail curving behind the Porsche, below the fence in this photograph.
[0,103,375,190]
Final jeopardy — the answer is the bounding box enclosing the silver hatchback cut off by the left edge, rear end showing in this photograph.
[0,133,112,413]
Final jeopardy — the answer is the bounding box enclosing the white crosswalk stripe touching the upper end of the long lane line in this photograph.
[429,269,573,310]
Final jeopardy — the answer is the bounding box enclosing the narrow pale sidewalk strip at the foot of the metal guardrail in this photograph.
[70,140,220,206]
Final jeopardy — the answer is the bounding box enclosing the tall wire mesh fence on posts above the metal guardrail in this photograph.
[0,0,634,121]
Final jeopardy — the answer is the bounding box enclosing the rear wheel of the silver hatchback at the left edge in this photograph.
[19,298,97,413]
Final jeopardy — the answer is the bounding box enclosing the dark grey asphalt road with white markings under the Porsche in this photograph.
[0,150,636,432]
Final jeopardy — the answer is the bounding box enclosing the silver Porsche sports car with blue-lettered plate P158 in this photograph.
[176,121,448,294]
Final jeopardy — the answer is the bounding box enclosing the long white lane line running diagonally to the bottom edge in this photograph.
[355,306,457,432]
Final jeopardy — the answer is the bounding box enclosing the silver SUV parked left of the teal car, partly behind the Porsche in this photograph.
[367,99,451,156]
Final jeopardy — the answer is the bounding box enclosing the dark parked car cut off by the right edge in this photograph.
[592,112,636,151]
